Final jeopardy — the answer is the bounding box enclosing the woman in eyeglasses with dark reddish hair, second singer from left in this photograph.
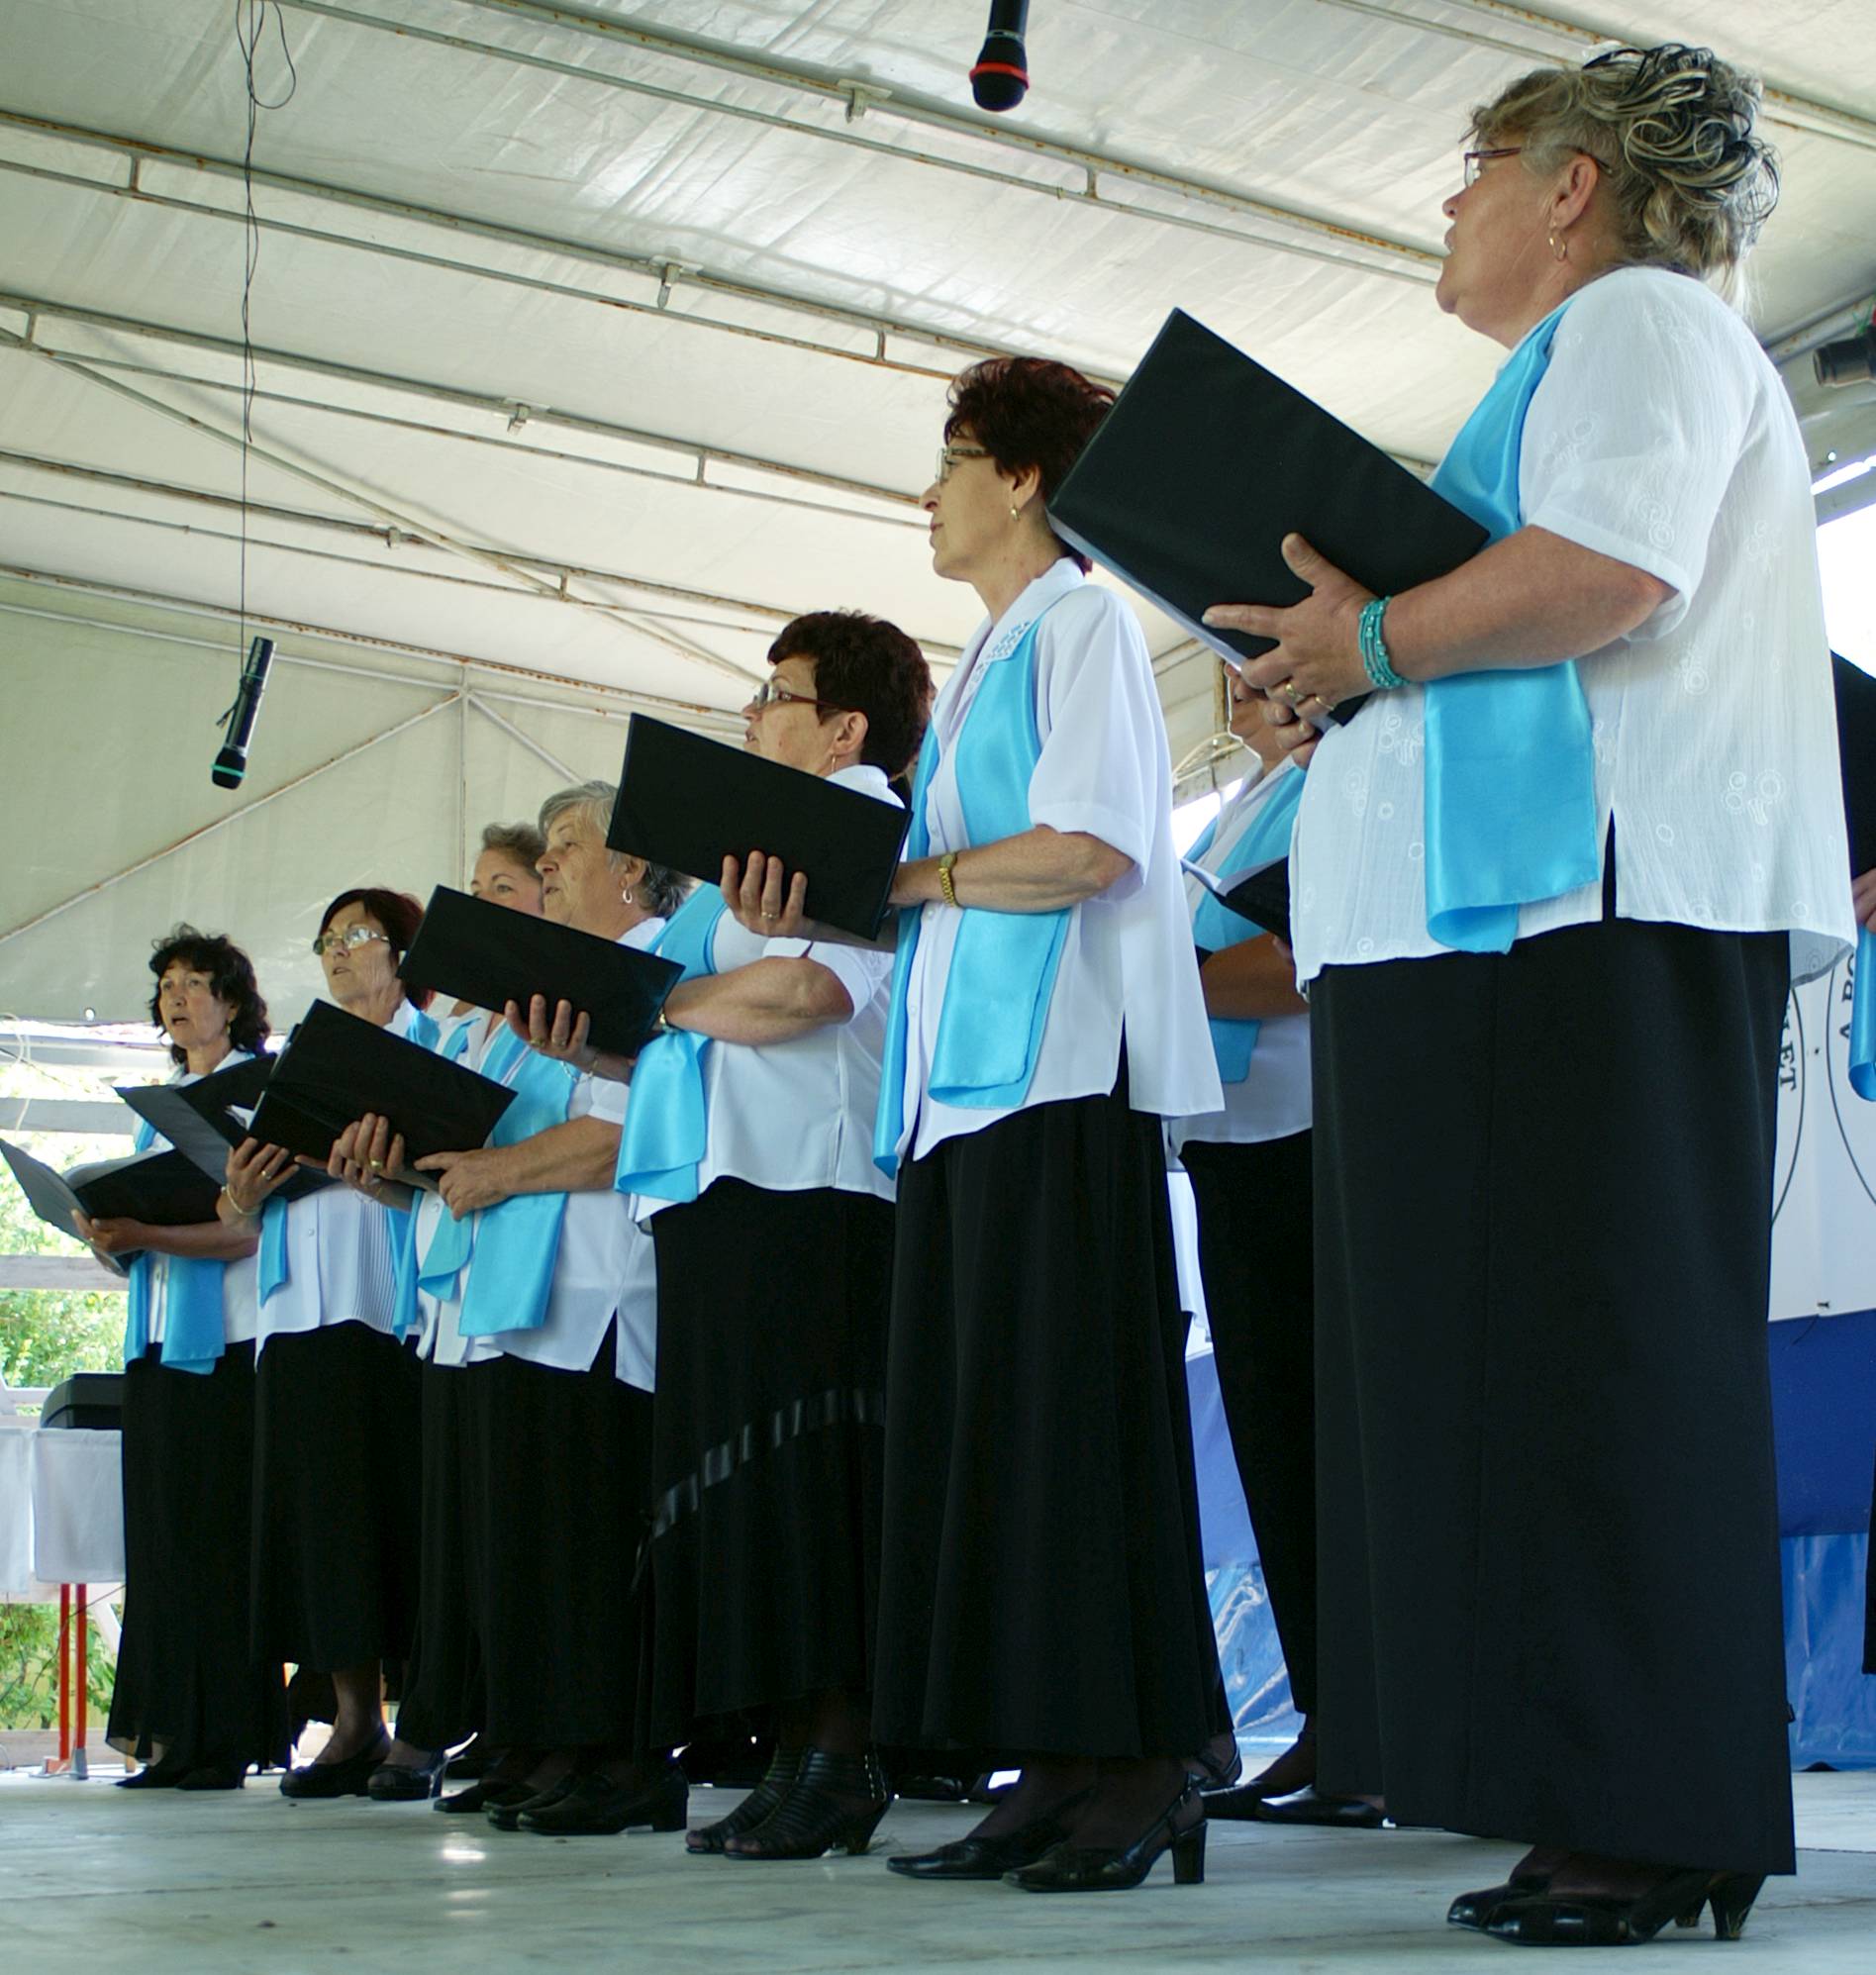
[217,887,437,1797]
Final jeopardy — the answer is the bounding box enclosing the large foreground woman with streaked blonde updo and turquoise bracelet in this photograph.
[1211,46,1854,1945]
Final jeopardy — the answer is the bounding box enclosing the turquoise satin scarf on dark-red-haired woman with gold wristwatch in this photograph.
[873,610,1068,1175]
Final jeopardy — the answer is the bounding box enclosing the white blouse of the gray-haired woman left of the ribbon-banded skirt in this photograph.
[461,919,665,1392]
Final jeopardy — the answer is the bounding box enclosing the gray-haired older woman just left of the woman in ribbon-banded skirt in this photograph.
[347,782,685,1834]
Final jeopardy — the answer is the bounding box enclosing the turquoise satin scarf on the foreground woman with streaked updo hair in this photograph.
[1426,302,1600,954]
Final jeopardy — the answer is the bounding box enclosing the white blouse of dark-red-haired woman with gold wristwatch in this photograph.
[899,557,1223,1159]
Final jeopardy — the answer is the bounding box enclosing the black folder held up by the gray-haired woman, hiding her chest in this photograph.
[399,885,683,1056]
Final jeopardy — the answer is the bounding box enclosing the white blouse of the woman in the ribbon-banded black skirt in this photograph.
[632,766,899,1223]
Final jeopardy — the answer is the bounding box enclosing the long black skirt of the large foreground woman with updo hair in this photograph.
[1312,919,1793,1872]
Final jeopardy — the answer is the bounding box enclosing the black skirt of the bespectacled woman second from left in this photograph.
[252,1324,423,1673]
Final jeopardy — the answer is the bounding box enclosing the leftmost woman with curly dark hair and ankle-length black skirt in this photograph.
[79,927,286,1791]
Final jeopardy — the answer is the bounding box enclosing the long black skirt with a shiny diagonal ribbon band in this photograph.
[647,1179,893,1744]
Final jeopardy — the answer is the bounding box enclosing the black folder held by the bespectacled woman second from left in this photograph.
[252,1001,516,1183]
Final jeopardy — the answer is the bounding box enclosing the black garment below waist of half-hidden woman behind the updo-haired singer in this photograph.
[1179,1132,1315,1715]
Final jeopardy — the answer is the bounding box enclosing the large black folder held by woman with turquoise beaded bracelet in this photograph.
[1048,308,1485,721]
